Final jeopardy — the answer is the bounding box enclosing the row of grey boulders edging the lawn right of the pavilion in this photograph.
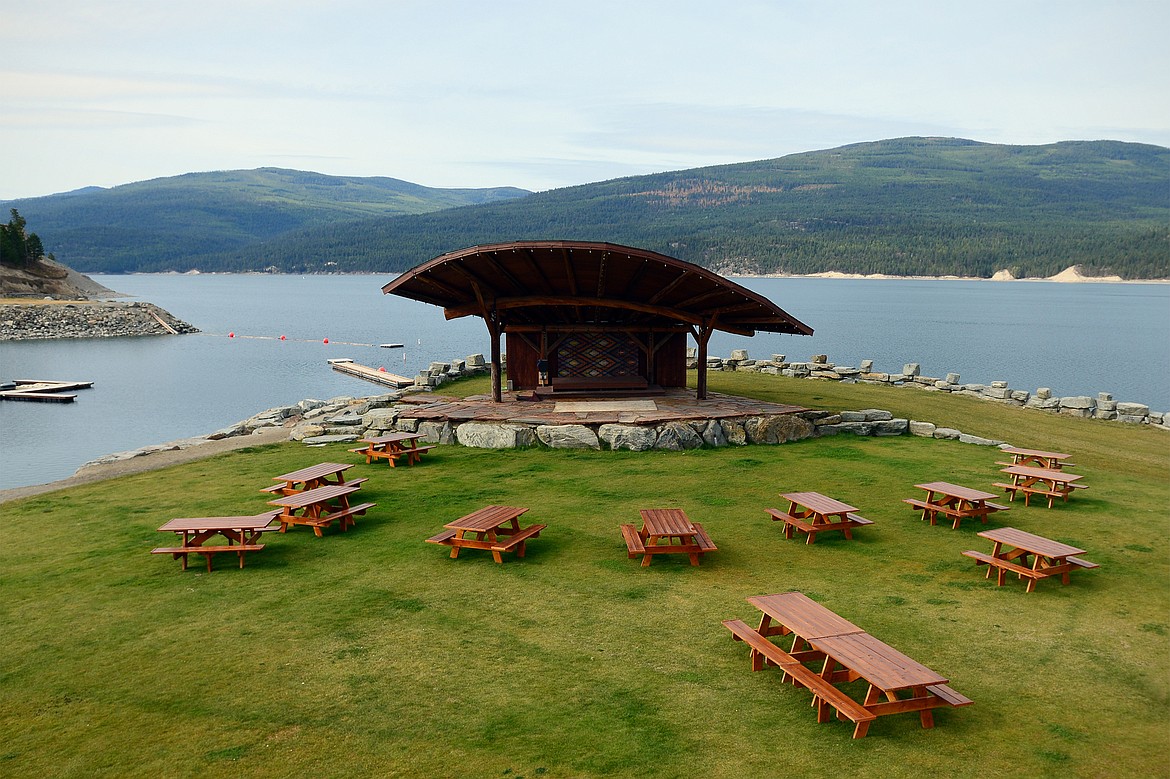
[687,349,1170,429]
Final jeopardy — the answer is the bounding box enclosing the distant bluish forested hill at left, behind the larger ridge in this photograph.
[0,167,529,273]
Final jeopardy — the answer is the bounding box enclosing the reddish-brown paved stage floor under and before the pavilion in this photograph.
[399,390,808,426]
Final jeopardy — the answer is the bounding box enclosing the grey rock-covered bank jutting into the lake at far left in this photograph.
[0,301,199,340]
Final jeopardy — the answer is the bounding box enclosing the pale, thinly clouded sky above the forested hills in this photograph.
[0,0,1170,199]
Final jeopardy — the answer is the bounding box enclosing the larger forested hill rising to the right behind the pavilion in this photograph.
[9,138,1170,278]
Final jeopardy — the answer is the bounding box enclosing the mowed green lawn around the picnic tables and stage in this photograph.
[0,374,1170,779]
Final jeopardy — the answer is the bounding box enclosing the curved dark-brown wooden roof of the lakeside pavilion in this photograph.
[381,241,812,336]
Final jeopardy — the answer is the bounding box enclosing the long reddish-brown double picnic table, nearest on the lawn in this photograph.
[723,592,971,738]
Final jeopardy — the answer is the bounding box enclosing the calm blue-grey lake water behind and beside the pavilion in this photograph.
[0,275,1170,489]
